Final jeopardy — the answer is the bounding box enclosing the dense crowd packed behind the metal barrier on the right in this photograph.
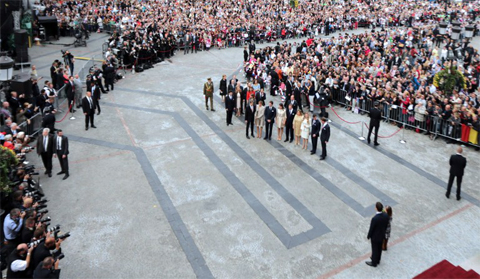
[225,23,480,150]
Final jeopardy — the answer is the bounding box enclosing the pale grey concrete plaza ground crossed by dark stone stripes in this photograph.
[18,29,480,278]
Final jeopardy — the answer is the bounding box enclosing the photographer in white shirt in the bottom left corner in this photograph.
[7,243,35,279]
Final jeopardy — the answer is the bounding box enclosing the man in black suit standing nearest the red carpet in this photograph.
[366,202,390,267]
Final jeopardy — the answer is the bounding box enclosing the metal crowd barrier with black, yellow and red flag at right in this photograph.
[331,88,480,147]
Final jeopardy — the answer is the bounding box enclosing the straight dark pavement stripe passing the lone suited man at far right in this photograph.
[330,122,480,207]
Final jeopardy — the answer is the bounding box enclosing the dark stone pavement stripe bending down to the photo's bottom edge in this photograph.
[68,135,214,278]
